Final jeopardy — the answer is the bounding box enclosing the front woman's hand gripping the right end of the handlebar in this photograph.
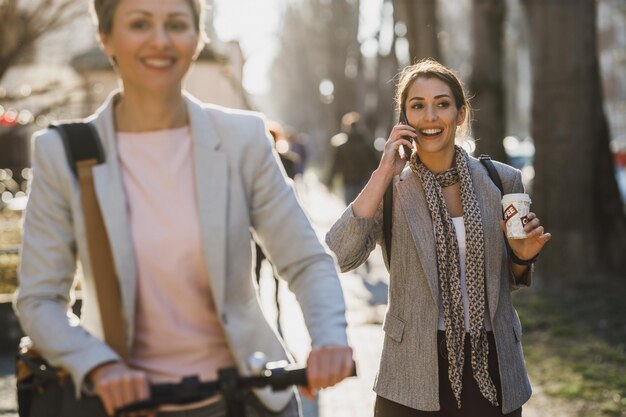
[300,346,354,400]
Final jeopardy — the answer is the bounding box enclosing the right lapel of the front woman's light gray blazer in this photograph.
[186,96,228,312]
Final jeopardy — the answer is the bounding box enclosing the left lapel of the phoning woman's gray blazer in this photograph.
[396,171,439,303]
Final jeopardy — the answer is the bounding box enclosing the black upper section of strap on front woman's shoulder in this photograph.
[50,122,104,177]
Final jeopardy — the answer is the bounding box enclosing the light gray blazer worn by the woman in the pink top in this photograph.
[15,90,347,410]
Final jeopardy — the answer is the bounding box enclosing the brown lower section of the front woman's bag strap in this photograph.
[76,159,128,360]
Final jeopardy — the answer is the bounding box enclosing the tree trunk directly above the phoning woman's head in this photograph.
[394,0,440,63]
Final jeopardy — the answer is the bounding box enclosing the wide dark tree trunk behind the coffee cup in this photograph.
[524,0,626,282]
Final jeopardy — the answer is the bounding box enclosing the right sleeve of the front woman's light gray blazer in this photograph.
[246,119,348,347]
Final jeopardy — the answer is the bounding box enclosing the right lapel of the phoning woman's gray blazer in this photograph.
[469,158,504,320]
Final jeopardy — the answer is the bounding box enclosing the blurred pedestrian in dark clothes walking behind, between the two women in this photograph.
[325,112,378,205]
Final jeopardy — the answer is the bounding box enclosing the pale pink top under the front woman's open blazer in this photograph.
[118,127,235,382]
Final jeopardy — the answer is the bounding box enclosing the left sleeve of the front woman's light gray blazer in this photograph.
[15,131,118,394]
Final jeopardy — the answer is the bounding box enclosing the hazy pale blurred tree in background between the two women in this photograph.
[270,0,360,165]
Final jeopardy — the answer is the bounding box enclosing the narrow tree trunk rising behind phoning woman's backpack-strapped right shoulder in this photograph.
[470,0,507,162]
